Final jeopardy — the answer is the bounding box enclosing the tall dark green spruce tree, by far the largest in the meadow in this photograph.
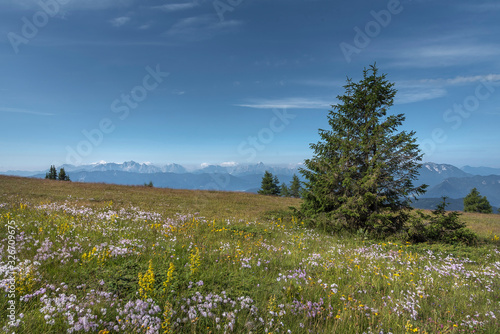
[300,65,426,233]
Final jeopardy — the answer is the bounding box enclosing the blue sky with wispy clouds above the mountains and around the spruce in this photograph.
[0,0,500,171]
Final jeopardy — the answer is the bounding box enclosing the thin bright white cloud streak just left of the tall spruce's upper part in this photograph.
[236,97,332,109]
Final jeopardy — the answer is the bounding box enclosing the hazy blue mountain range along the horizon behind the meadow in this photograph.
[0,161,500,210]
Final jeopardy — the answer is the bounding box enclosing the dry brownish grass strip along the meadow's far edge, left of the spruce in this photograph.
[0,176,300,220]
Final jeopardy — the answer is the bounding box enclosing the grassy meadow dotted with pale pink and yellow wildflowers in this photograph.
[0,176,500,334]
